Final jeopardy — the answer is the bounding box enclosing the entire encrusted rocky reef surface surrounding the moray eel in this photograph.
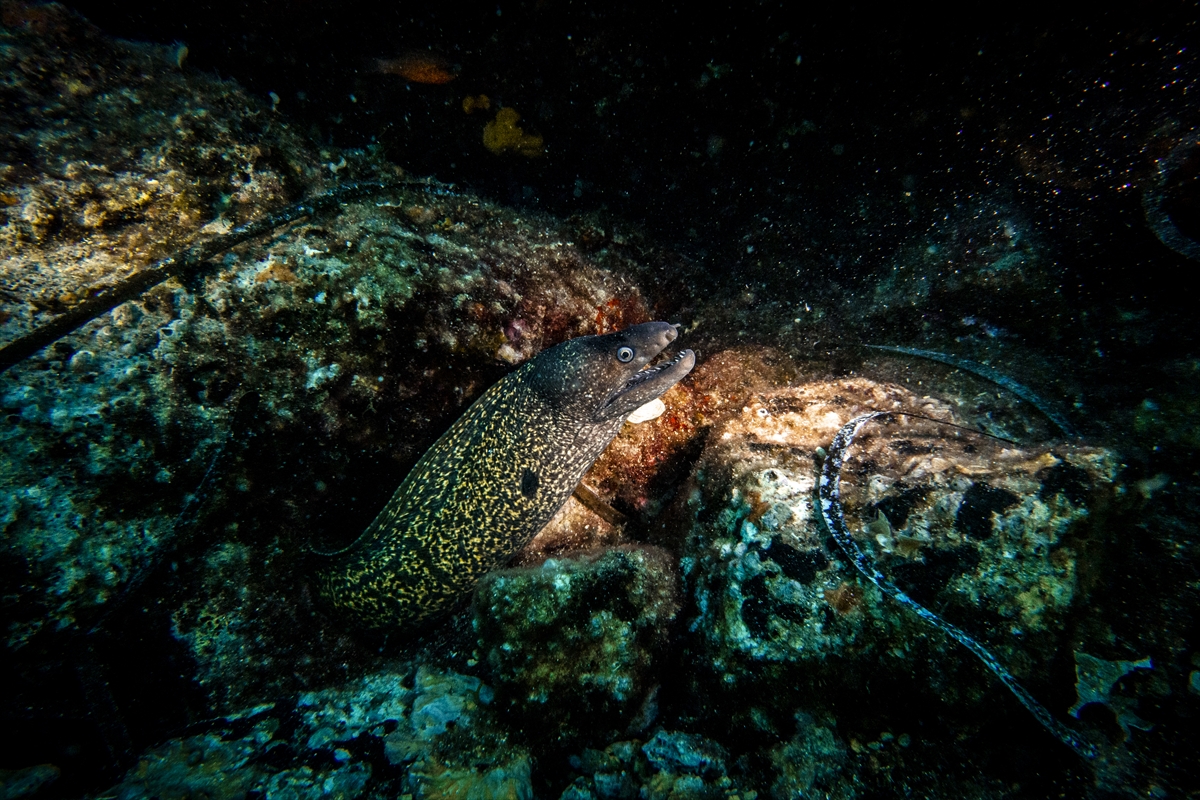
[0,6,1200,800]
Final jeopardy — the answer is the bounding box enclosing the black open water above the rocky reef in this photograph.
[54,1,1200,355]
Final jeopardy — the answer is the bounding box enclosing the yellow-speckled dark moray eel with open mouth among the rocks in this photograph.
[322,323,696,630]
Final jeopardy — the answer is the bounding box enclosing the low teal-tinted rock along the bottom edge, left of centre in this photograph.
[104,666,533,800]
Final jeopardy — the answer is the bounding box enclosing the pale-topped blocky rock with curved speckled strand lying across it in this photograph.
[676,379,1117,732]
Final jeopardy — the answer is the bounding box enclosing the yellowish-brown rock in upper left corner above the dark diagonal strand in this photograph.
[0,1,324,331]
